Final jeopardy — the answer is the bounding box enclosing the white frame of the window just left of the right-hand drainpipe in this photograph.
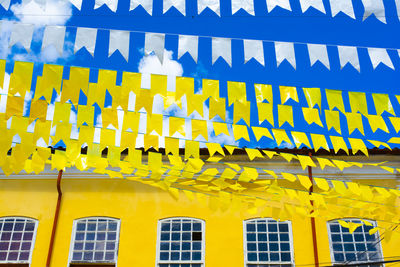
[243,218,295,267]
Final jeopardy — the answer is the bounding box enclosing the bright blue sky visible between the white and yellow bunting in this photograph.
[0,0,400,151]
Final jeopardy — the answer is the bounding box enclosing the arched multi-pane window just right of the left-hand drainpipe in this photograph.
[69,217,120,266]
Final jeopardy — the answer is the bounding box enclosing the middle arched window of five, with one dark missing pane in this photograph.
[157,218,205,267]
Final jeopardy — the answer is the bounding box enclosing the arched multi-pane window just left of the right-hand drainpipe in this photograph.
[244,218,294,267]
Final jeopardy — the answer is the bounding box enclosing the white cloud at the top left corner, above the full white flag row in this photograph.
[10,0,72,25]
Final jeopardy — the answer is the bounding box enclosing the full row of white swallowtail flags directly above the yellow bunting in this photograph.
[0,22,400,71]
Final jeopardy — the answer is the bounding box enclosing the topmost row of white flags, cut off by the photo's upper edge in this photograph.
[0,0,400,23]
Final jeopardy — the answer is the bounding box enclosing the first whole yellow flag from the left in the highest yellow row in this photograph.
[8,61,34,97]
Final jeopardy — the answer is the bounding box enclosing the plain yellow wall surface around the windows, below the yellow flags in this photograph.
[0,179,400,267]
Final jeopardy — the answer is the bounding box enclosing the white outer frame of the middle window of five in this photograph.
[155,217,206,267]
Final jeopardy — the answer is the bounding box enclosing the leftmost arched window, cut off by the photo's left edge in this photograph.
[0,217,38,266]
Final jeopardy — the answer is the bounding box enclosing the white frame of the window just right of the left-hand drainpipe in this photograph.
[67,216,121,267]
